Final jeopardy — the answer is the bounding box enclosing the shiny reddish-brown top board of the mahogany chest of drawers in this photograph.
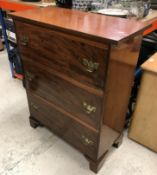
[11,7,150,43]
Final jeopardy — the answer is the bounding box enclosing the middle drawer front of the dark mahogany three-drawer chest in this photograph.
[24,61,103,129]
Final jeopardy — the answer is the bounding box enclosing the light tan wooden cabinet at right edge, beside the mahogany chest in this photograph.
[129,53,157,152]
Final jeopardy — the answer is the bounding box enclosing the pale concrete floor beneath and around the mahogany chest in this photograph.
[0,52,157,175]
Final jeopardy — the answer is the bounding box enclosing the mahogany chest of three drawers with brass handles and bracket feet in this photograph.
[11,7,148,172]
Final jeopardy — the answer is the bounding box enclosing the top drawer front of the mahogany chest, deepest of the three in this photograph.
[16,21,108,88]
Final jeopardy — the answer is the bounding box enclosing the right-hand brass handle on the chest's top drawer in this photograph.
[82,58,99,72]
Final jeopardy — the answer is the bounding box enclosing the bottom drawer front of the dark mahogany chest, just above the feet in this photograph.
[28,93,98,159]
